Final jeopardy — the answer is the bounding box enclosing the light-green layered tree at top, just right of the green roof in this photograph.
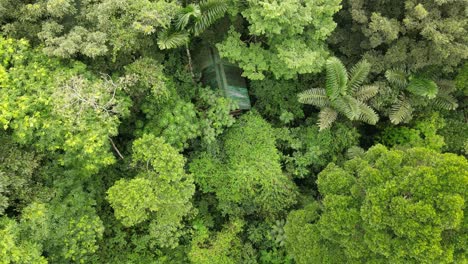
[217,0,341,80]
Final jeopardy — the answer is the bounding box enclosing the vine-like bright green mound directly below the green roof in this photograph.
[190,113,296,217]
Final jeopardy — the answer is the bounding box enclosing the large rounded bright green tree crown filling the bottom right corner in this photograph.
[285,145,468,263]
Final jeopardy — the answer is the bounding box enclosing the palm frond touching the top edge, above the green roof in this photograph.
[191,0,228,36]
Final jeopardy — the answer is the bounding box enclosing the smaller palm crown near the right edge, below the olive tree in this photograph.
[385,69,458,124]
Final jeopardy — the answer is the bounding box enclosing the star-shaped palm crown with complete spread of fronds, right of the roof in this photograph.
[298,57,379,130]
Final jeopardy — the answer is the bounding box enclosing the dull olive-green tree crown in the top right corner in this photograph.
[330,0,468,73]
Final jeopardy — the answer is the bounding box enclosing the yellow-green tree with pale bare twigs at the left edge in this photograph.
[0,39,130,176]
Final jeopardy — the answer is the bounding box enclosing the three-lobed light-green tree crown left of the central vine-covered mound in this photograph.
[107,134,195,247]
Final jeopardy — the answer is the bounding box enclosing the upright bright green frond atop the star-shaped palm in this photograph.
[325,57,348,101]
